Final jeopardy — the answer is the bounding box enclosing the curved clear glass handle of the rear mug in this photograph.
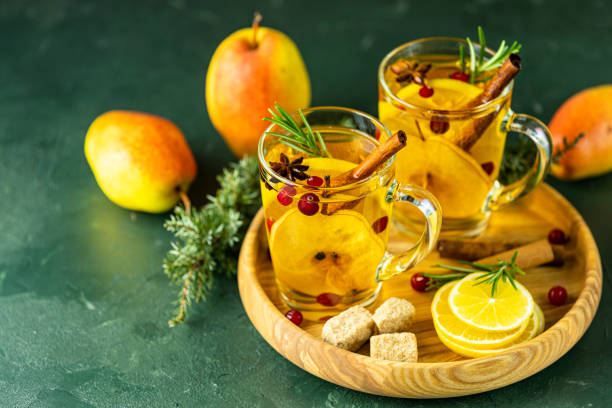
[487,111,552,210]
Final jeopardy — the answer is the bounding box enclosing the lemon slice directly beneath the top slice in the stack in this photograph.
[431,282,529,350]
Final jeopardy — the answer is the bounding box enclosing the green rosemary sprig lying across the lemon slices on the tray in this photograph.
[423,251,525,297]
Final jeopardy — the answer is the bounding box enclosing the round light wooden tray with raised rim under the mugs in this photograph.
[238,185,602,398]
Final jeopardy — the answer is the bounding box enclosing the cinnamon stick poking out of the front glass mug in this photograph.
[321,130,406,215]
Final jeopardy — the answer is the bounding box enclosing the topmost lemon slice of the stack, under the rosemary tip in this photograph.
[448,273,534,331]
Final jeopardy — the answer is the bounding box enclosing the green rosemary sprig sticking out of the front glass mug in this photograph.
[263,103,331,157]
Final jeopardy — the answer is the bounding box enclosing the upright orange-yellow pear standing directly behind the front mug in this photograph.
[206,14,310,157]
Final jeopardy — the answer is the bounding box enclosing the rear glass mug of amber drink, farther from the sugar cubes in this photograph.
[378,38,552,237]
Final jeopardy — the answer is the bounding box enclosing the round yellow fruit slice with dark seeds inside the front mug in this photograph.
[270,208,385,296]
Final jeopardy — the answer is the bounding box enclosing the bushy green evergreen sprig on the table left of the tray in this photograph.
[163,157,259,327]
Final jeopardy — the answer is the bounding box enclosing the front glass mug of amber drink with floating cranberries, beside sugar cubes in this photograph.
[258,107,441,318]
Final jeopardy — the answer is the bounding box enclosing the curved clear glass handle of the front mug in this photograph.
[376,181,442,282]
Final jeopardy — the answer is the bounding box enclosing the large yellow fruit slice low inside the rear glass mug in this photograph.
[396,135,492,218]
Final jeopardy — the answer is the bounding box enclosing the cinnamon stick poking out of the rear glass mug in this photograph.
[452,54,521,152]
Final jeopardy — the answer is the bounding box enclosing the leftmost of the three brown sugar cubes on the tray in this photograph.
[321,306,374,351]
